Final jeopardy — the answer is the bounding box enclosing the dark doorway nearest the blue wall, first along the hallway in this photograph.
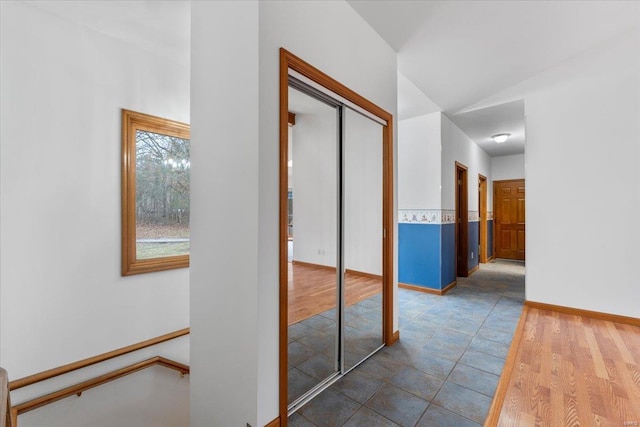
[453,162,469,277]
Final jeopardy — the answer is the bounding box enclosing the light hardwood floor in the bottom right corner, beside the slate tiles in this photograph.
[485,307,640,427]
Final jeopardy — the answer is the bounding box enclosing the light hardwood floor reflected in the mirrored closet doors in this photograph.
[288,263,382,325]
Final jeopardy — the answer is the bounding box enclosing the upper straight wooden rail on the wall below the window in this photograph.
[9,328,189,392]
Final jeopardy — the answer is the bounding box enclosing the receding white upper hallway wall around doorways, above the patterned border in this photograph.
[442,115,493,211]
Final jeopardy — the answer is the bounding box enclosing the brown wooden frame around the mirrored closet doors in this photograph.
[279,48,399,426]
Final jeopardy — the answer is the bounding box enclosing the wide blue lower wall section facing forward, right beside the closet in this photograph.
[398,223,441,289]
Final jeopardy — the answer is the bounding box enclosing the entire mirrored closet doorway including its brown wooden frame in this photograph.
[280,49,397,425]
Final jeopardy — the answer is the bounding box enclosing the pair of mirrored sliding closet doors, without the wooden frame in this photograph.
[287,77,384,412]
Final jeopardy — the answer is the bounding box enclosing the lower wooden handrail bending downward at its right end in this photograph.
[13,356,189,420]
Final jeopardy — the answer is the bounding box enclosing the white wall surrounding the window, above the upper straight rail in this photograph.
[0,2,189,378]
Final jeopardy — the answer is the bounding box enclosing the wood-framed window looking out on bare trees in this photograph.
[122,110,191,276]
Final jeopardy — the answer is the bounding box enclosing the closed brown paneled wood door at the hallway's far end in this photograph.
[493,179,525,260]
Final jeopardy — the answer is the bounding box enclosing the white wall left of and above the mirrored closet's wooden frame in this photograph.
[258,1,397,424]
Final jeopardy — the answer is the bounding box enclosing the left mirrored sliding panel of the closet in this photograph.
[288,88,338,403]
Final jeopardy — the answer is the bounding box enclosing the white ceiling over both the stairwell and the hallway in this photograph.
[27,0,640,156]
